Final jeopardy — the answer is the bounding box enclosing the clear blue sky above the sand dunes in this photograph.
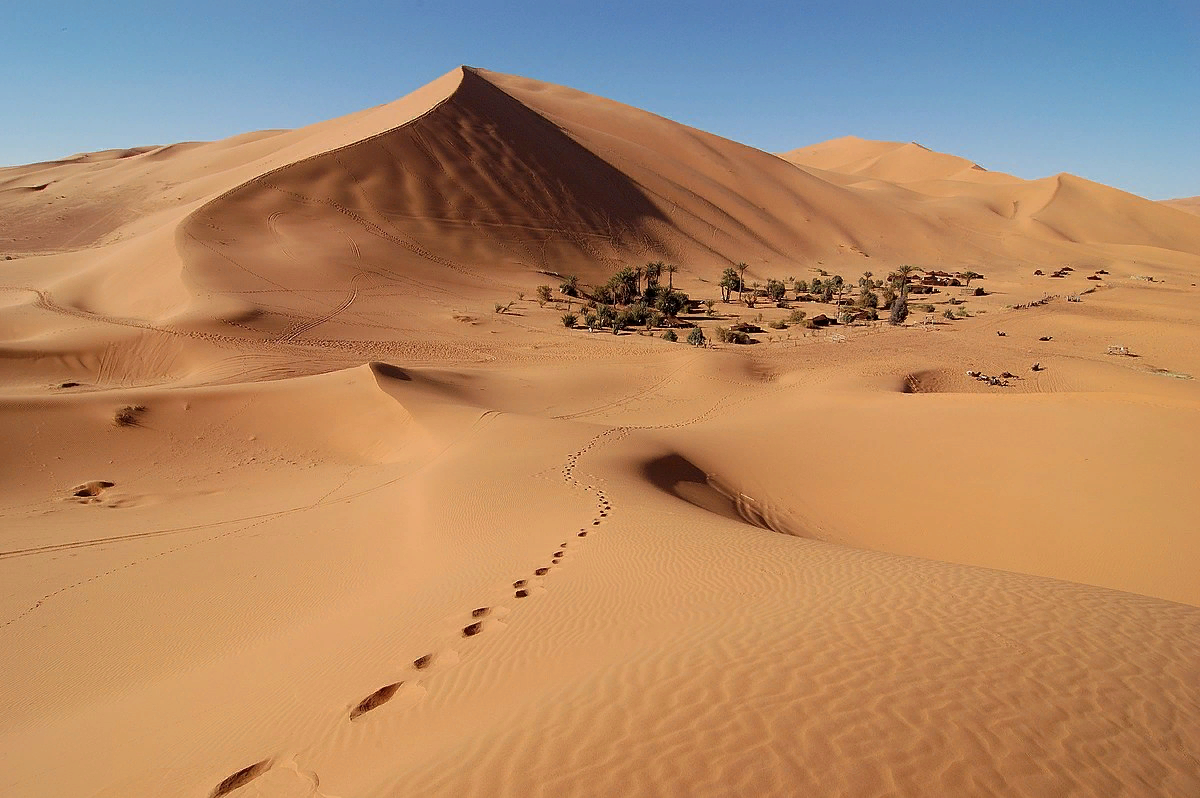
[0,0,1200,199]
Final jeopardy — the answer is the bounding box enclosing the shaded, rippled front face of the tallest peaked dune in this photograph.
[179,70,665,307]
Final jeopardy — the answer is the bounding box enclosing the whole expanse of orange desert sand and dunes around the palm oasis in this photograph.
[0,67,1200,798]
